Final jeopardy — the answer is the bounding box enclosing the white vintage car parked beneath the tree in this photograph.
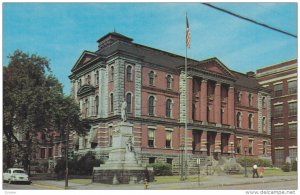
[3,168,31,184]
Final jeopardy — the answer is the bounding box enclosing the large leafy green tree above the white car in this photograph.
[3,50,88,172]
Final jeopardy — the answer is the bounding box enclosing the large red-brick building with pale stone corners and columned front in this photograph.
[69,32,271,172]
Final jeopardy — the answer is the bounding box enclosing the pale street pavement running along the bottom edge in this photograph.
[3,180,298,190]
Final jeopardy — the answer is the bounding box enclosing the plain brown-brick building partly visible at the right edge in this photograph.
[256,59,298,166]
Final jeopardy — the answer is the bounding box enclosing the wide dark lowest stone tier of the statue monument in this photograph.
[93,168,154,184]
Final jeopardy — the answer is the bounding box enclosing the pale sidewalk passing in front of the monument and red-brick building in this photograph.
[32,175,297,190]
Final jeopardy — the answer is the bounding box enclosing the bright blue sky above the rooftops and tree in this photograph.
[2,2,298,95]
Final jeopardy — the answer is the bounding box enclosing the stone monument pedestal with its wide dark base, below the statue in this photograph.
[93,122,154,184]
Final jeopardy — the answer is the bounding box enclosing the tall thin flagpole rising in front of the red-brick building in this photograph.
[184,13,188,179]
